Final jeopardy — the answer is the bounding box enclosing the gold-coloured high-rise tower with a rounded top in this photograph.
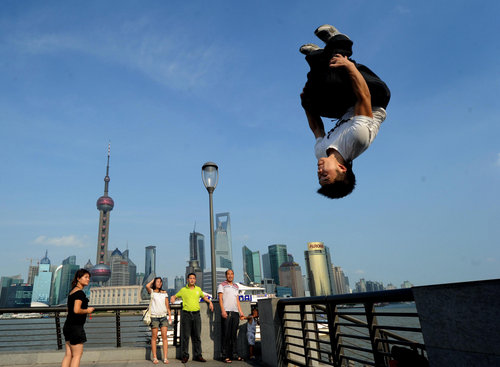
[304,242,334,297]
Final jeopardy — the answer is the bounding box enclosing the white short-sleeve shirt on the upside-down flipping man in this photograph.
[314,107,387,162]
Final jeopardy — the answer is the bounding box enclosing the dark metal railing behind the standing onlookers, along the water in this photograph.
[0,305,180,352]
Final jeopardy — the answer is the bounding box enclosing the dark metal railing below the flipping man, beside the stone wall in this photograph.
[276,289,426,366]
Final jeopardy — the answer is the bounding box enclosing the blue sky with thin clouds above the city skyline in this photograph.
[0,1,500,286]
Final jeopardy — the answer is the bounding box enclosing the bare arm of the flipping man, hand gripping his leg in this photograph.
[330,54,373,117]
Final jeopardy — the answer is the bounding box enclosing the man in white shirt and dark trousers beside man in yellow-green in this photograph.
[217,269,245,363]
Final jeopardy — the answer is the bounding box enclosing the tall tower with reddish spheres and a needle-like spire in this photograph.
[90,144,115,284]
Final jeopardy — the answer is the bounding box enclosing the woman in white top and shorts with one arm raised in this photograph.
[146,277,172,364]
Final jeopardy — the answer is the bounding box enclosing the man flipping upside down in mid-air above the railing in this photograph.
[300,25,390,199]
